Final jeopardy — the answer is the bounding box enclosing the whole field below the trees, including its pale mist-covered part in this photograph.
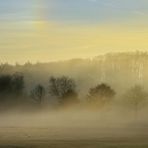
[0,110,148,148]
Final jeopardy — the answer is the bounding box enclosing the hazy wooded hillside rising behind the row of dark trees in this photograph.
[0,52,148,95]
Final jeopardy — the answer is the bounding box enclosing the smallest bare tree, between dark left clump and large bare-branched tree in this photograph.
[31,84,45,104]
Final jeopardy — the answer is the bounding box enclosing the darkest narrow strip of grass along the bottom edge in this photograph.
[0,139,148,148]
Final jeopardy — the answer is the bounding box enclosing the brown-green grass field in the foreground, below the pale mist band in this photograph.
[0,127,148,148]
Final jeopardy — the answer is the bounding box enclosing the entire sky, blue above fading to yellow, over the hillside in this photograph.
[0,0,148,64]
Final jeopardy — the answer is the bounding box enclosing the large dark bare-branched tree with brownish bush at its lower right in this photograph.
[49,76,78,104]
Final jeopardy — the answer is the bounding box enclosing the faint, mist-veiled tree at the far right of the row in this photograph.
[124,85,148,118]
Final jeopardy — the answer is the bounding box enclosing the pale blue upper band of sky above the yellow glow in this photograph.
[0,0,148,23]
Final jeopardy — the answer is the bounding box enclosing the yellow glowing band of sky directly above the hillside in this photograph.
[0,21,148,64]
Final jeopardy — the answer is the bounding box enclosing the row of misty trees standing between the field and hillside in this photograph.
[0,73,148,112]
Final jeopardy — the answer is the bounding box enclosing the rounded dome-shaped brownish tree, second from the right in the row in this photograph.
[88,83,116,104]
